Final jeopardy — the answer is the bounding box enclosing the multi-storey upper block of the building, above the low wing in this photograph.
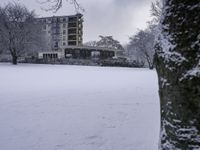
[38,14,83,51]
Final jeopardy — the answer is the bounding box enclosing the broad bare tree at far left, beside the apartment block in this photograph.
[0,3,46,64]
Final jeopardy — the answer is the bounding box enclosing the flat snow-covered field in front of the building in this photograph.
[0,64,159,150]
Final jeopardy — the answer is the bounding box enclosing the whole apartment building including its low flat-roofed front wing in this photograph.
[38,14,122,59]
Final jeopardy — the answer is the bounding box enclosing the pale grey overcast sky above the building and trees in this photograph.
[0,0,153,44]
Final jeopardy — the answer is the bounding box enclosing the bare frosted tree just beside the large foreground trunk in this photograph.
[127,28,155,69]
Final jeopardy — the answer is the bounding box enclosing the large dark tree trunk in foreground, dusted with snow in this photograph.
[155,0,200,150]
